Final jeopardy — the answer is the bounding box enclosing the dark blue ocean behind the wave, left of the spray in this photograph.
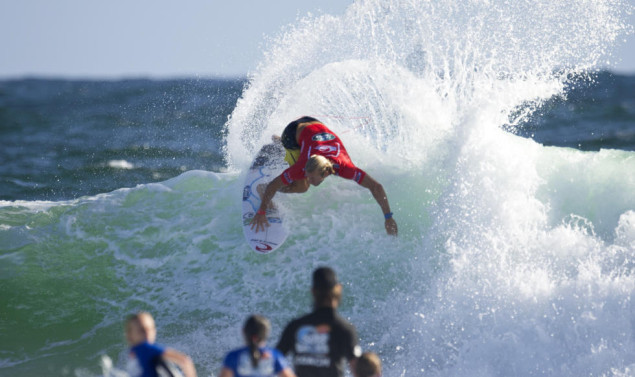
[0,79,245,200]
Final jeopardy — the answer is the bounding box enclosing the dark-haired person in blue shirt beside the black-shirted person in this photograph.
[219,315,296,377]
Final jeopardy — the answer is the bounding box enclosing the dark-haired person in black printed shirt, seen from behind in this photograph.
[276,267,362,377]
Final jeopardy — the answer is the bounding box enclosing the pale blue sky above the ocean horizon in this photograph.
[0,0,635,79]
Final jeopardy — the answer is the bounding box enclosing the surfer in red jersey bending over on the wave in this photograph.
[251,117,397,236]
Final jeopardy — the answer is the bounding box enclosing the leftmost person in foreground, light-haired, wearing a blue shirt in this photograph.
[126,312,196,377]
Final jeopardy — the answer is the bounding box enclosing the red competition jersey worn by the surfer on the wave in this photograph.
[281,123,366,185]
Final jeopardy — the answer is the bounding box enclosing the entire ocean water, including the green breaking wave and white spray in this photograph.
[0,0,635,377]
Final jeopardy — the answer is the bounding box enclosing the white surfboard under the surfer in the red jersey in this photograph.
[243,143,288,254]
